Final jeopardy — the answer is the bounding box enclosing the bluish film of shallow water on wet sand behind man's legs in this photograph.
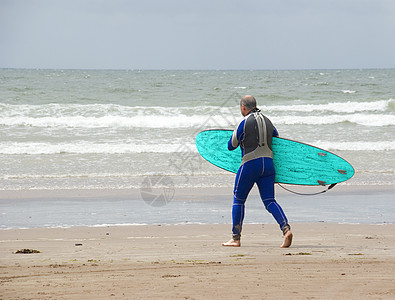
[0,189,395,227]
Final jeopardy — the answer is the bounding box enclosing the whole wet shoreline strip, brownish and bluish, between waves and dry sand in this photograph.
[0,185,395,230]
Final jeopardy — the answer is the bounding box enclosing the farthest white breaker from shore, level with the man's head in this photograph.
[0,100,395,121]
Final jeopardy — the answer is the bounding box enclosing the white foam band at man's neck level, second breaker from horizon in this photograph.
[0,110,395,128]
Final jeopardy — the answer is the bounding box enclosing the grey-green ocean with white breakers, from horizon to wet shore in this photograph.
[0,69,395,227]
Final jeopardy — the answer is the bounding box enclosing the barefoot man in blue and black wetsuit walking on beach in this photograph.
[222,95,293,248]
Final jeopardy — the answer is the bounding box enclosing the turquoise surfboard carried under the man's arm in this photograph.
[195,130,354,186]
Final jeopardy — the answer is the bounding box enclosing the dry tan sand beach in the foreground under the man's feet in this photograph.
[0,223,395,299]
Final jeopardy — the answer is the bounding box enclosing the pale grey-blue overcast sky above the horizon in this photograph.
[0,0,395,70]
